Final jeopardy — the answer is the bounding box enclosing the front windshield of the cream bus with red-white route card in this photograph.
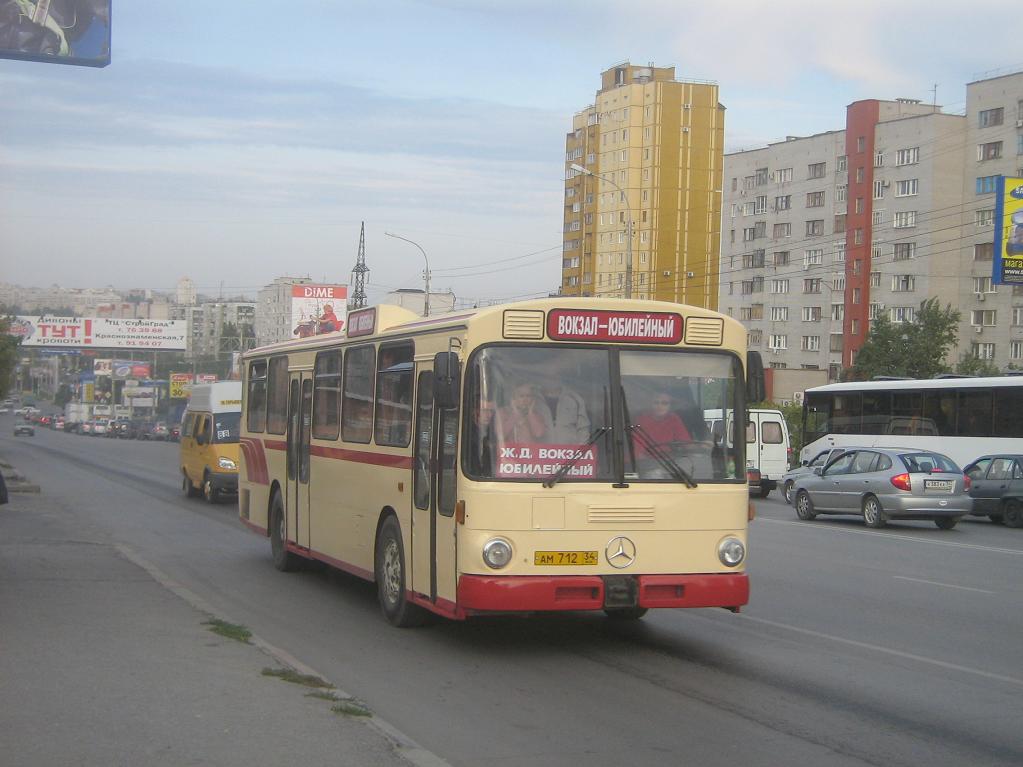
[464,346,745,484]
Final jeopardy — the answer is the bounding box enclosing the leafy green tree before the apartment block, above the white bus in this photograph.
[852,299,962,380]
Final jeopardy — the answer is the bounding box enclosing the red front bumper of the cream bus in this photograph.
[458,573,750,612]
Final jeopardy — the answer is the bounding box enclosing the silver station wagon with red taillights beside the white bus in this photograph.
[793,448,973,530]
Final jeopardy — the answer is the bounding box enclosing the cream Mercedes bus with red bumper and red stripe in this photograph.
[238,299,762,626]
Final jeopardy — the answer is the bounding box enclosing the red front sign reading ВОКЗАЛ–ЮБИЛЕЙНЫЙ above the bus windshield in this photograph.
[547,309,682,345]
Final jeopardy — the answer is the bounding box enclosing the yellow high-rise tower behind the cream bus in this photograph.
[562,62,724,309]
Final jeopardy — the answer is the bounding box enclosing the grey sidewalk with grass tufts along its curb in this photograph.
[0,460,431,767]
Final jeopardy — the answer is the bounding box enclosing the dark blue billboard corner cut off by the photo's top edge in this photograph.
[0,0,110,66]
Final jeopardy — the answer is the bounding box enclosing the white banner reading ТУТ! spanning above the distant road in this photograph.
[9,317,188,352]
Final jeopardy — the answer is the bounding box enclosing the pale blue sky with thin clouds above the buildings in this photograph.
[0,0,1023,303]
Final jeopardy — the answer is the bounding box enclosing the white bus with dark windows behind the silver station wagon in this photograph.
[800,376,1023,467]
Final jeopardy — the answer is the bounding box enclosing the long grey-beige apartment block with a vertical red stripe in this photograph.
[720,74,1023,379]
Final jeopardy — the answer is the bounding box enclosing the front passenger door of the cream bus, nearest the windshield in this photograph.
[410,366,458,607]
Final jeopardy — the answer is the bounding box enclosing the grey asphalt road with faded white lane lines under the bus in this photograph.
[0,427,1023,767]
